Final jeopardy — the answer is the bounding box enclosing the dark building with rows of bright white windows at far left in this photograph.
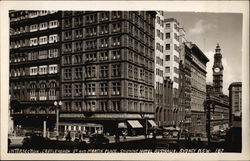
[9,10,61,135]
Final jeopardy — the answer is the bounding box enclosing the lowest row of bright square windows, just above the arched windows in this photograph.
[29,64,58,75]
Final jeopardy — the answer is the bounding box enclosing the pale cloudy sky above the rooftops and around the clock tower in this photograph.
[165,12,242,94]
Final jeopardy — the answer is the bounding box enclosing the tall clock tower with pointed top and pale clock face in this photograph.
[213,44,223,94]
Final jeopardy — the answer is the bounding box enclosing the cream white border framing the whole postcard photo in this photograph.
[0,1,250,160]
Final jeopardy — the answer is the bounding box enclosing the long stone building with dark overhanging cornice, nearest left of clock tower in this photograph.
[188,43,209,135]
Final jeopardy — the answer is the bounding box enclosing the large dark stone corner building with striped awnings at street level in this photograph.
[60,11,156,134]
